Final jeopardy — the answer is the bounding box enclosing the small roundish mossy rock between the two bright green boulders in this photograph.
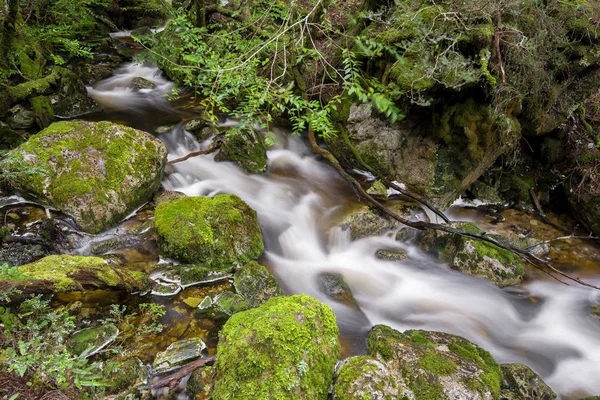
[233,261,281,307]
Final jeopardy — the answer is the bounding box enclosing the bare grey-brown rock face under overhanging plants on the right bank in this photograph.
[328,102,520,208]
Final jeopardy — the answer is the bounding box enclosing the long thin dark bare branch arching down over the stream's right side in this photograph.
[308,129,600,290]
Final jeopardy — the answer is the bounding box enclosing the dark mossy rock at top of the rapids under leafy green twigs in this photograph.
[215,129,267,173]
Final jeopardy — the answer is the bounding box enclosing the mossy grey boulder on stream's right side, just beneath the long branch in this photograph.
[419,222,525,287]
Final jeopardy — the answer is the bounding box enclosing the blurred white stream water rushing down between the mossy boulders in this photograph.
[83,64,600,399]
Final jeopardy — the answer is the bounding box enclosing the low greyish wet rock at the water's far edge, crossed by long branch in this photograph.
[336,201,427,240]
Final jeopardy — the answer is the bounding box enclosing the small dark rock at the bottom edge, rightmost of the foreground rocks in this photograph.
[500,364,556,400]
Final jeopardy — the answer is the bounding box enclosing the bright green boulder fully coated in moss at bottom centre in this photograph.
[212,295,340,400]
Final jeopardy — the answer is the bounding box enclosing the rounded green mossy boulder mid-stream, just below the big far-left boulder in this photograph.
[154,194,264,268]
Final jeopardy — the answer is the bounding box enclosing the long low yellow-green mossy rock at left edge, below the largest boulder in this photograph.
[0,255,149,293]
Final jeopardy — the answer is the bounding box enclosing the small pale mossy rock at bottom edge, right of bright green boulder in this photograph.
[332,356,410,400]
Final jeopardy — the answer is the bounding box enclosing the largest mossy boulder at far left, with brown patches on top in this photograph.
[8,121,167,233]
